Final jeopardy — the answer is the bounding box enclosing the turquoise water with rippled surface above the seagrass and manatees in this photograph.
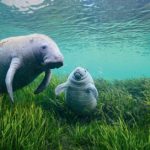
[0,0,150,79]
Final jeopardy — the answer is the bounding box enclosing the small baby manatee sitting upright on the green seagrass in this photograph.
[55,67,98,114]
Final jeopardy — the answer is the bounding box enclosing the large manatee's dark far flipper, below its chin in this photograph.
[34,69,51,94]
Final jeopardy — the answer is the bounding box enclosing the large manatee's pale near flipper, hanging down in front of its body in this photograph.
[5,57,21,102]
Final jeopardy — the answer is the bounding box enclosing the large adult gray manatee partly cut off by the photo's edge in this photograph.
[0,34,63,102]
